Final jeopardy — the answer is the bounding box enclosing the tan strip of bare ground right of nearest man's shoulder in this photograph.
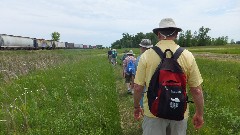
[193,53,240,62]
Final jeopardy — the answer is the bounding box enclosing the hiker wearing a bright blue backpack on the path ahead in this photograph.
[123,50,136,94]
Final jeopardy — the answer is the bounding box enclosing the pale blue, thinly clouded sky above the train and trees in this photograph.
[0,0,240,46]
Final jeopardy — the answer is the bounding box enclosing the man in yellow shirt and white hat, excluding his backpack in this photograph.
[134,18,204,135]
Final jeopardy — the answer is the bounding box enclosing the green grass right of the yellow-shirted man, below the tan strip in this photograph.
[188,59,240,135]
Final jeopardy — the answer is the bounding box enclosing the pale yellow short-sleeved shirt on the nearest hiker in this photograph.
[134,40,203,118]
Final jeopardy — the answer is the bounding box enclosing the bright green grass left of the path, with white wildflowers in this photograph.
[0,50,122,135]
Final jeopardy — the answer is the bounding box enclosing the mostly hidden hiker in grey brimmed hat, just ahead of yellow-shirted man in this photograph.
[136,39,153,108]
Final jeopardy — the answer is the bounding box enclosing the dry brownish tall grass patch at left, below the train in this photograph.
[0,50,72,83]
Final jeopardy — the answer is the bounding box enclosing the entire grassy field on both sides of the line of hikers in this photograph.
[0,45,240,135]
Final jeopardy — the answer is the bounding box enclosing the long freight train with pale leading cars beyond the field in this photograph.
[0,34,96,50]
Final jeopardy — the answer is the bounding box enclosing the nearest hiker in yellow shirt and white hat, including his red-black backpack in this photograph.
[134,18,204,135]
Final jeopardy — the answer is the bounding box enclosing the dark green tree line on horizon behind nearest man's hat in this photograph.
[111,26,240,49]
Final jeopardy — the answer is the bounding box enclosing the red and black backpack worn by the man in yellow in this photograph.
[147,46,187,121]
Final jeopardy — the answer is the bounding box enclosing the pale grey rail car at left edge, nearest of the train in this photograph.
[0,34,34,48]
